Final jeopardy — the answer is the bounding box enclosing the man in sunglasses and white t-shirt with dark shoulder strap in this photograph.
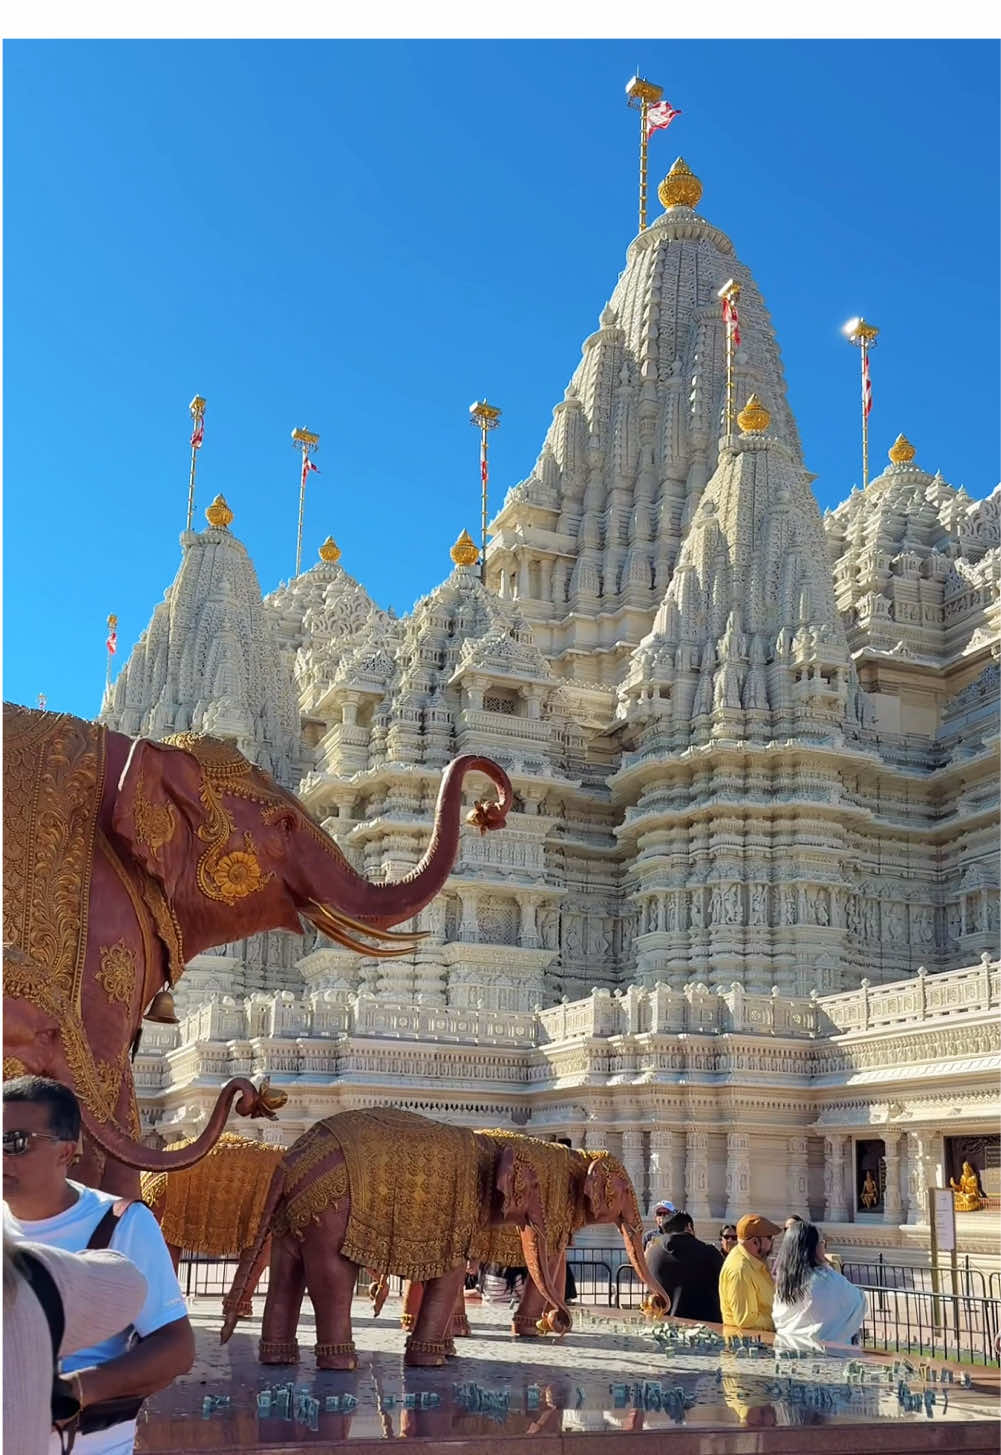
[3,1077,195,1455]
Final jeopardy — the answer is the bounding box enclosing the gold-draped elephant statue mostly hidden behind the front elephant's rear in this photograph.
[141,1132,285,1318]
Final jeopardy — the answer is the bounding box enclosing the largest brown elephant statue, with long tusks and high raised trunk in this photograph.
[3,703,512,1196]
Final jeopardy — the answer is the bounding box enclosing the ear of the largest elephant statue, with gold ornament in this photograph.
[112,738,205,896]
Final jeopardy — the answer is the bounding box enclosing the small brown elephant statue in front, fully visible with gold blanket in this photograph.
[221,1107,569,1369]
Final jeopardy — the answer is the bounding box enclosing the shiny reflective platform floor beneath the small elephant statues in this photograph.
[137,1298,998,1455]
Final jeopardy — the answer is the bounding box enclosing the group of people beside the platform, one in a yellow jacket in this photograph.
[645,1202,866,1347]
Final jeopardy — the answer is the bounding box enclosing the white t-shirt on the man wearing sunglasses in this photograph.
[3,1181,188,1455]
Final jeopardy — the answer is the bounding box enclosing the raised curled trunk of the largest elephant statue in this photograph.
[301,754,514,953]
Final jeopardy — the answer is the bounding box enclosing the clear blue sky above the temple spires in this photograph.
[3,41,1000,716]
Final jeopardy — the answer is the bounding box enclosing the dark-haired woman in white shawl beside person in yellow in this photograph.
[771,1222,866,1347]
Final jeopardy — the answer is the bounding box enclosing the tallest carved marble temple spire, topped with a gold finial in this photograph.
[487,159,800,691]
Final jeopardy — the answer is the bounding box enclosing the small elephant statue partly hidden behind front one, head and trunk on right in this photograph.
[400,1131,671,1339]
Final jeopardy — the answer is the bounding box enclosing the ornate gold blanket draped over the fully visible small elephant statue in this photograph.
[275,1107,493,1282]
